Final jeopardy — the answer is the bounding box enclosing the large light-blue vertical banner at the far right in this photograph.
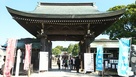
[117,38,130,76]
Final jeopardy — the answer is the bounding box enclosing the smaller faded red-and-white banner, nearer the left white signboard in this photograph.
[24,44,32,70]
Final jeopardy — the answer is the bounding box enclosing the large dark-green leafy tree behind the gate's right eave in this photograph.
[104,4,136,43]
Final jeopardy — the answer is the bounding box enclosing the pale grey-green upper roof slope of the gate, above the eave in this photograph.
[31,3,99,14]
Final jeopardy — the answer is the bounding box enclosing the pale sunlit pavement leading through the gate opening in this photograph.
[0,63,115,77]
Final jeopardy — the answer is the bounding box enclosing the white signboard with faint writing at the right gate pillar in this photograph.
[84,53,94,73]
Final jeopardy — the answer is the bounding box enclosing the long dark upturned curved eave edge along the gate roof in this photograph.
[6,7,125,19]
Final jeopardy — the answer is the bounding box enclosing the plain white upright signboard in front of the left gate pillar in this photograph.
[39,51,48,71]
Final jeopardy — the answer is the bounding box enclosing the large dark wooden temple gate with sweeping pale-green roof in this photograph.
[7,2,125,71]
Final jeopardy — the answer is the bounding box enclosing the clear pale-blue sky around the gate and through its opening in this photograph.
[0,0,135,47]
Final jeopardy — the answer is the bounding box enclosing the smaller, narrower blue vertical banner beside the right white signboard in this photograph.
[96,46,103,71]
